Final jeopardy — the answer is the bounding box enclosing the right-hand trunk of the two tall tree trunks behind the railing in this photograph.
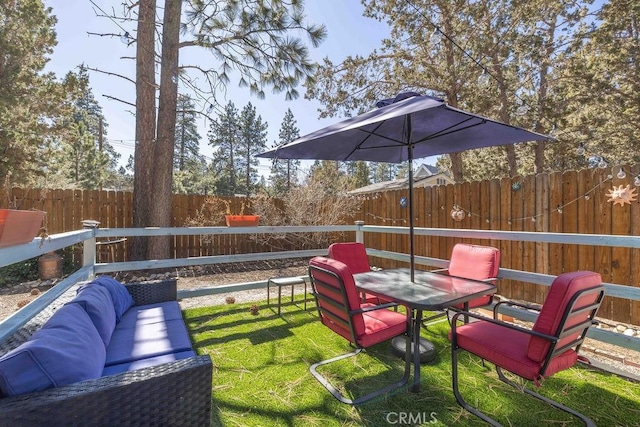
[148,0,182,259]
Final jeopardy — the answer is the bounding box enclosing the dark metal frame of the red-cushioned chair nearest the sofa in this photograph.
[309,266,411,405]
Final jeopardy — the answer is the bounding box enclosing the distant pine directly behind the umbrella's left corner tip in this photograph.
[238,103,268,196]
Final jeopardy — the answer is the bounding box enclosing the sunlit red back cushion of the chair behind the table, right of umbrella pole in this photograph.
[449,243,500,280]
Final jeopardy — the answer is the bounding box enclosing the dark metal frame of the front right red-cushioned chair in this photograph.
[451,285,604,427]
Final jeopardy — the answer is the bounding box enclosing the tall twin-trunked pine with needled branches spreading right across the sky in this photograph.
[132,0,326,259]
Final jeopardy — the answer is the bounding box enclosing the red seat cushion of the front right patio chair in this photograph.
[449,321,578,381]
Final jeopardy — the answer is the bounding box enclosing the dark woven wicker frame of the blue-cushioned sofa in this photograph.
[0,280,213,426]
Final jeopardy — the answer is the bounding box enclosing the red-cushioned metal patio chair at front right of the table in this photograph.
[449,271,604,426]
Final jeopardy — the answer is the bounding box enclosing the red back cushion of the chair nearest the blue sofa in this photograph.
[309,257,364,340]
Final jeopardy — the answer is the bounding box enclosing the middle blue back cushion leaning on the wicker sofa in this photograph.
[67,283,116,348]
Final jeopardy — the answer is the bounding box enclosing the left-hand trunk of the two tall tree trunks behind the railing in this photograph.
[131,0,156,260]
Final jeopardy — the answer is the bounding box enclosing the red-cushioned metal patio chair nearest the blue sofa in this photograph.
[309,257,411,405]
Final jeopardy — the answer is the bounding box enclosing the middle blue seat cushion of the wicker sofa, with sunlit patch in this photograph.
[105,319,191,366]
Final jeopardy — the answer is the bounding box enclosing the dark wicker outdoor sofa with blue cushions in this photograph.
[0,276,212,426]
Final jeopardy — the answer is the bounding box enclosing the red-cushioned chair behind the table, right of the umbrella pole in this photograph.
[424,243,500,322]
